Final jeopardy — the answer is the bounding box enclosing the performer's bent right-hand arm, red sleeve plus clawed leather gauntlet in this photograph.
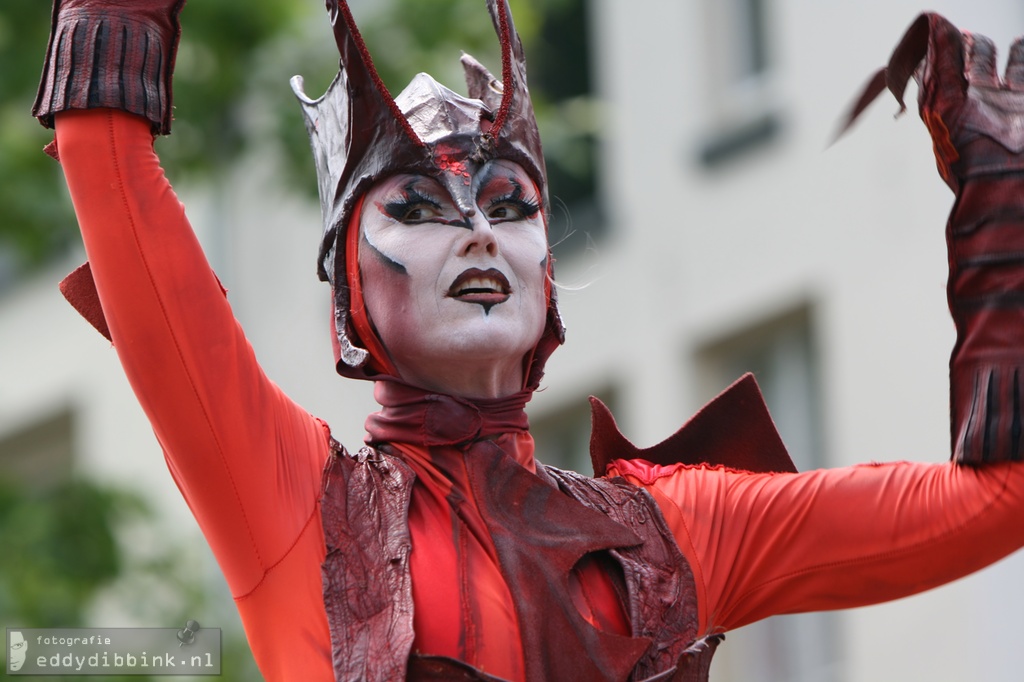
[617,13,1024,631]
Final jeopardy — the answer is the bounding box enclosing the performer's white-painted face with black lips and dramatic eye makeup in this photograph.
[358,160,548,397]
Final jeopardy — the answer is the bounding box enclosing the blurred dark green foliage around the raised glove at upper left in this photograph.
[0,0,311,266]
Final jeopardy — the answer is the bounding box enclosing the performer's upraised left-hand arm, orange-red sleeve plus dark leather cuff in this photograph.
[35,0,328,597]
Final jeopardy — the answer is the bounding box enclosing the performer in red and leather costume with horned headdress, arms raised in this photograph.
[29,0,1024,681]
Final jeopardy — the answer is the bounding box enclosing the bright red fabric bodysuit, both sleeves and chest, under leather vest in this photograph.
[57,110,1024,681]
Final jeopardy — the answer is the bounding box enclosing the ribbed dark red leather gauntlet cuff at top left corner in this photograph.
[32,0,185,134]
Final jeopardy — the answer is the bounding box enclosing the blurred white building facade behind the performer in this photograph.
[0,0,1024,682]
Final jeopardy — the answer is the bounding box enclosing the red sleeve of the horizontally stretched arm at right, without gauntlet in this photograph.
[609,460,1024,634]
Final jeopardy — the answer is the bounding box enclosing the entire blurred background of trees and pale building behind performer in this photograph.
[0,0,1024,682]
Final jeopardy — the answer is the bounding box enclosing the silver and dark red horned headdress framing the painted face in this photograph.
[292,0,564,386]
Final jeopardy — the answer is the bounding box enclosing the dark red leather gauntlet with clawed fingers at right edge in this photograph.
[850,13,1024,464]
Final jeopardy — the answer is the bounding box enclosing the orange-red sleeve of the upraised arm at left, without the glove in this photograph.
[56,110,328,597]
